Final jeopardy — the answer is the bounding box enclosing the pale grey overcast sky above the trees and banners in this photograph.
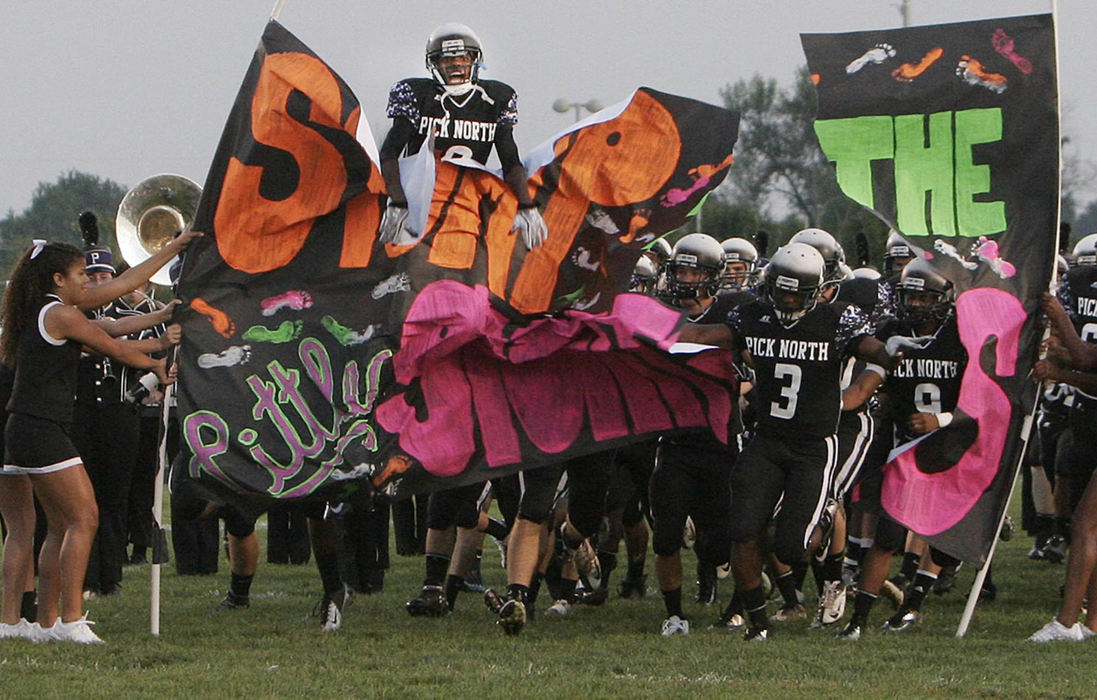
[0,0,1079,217]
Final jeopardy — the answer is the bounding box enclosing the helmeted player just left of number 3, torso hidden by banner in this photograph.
[648,233,742,636]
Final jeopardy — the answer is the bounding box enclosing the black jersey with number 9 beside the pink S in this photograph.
[880,314,968,442]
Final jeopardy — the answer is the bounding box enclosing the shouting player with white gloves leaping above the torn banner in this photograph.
[380,22,549,249]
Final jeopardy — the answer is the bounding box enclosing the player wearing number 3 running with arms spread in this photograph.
[678,244,906,641]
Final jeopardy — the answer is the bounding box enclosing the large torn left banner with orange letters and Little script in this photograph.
[178,22,738,501]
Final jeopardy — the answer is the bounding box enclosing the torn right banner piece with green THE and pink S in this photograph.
[801,14,1060,564]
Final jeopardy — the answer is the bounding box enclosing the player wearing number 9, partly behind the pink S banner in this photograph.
[838,259,968,641]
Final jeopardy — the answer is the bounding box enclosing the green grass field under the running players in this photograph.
[0,491,1097,698]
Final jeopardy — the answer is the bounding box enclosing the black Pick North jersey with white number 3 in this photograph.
[727,301,874,439]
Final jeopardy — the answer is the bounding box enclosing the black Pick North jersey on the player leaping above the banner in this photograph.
[388,78,518,165]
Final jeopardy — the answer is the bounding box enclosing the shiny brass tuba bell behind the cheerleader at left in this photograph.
[114,173,202,286]
